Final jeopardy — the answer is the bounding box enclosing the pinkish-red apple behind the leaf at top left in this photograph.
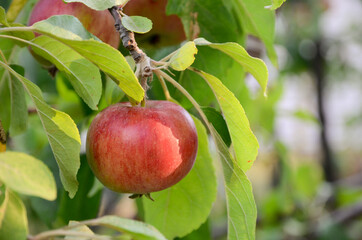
[28,0,120,48]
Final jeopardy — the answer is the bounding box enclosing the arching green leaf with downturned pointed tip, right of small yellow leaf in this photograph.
[194,38,268,95]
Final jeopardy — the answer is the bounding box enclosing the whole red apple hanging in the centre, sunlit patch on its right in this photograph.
[86,100,198,194]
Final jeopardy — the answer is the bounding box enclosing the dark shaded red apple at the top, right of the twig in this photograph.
[123,0,186,48]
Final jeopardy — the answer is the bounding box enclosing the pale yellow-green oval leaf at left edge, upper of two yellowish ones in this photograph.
[0,151,57,200]
